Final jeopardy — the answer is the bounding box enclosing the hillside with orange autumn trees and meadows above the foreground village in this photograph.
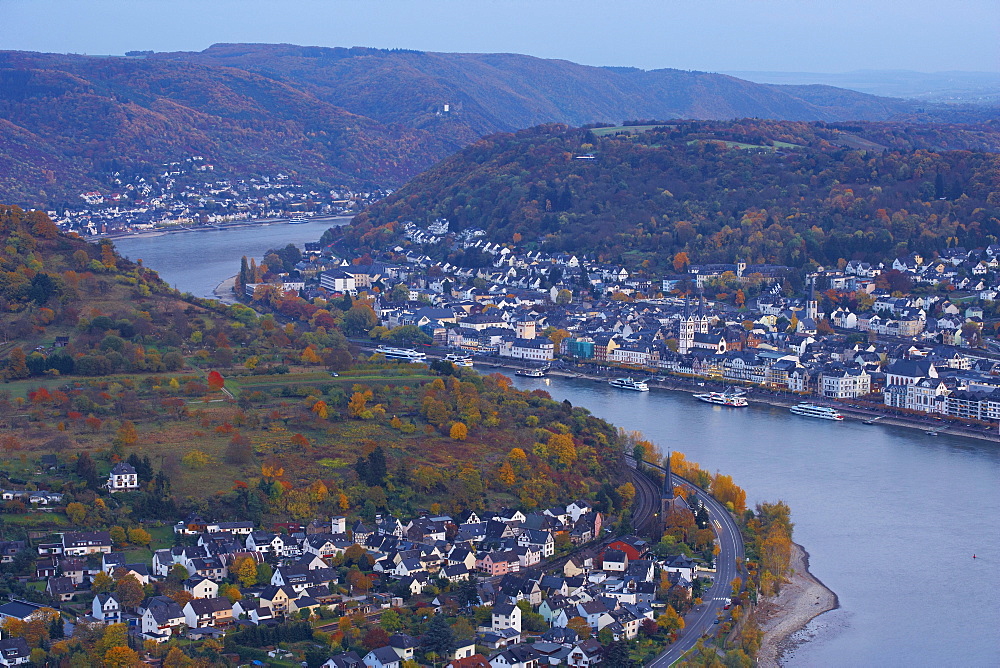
[0,207,622,528]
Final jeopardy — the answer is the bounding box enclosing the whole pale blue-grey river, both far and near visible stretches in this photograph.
[115,222,1000,666]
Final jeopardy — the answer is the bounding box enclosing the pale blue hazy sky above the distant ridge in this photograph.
[0,0,1000,72]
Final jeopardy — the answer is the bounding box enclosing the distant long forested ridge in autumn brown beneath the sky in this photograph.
[0,44,983,206]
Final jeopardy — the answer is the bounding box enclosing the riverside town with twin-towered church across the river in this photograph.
[242,220,1000,426]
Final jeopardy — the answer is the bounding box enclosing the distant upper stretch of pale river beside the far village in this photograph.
[115,218,349,297]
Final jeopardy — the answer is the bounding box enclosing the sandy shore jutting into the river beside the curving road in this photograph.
[754,543,840,668]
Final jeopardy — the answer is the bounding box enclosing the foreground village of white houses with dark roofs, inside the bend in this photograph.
[0,454,708,668]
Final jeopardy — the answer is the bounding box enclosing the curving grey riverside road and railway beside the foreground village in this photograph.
[628,458,746,668]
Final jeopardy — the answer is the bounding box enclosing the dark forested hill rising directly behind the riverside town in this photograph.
[340,120,1000,268]
